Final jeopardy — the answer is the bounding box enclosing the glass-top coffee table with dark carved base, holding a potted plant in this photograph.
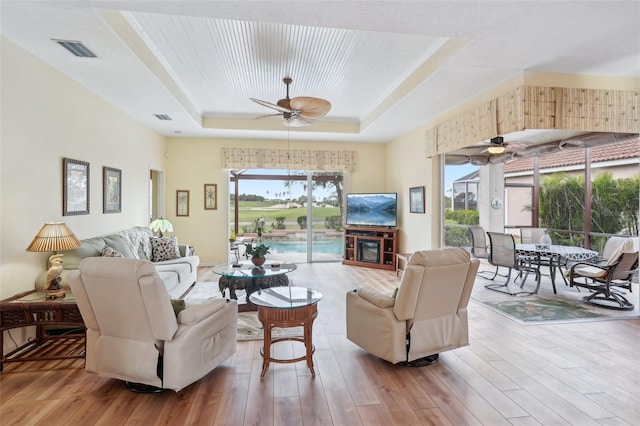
[213,262,297,311]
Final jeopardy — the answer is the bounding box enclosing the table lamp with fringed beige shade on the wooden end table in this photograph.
[27,222,80,299]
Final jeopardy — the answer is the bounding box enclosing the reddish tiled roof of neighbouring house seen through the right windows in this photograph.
[504,138,640,173]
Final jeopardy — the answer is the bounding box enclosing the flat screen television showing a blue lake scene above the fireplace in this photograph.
[346,192,398,228]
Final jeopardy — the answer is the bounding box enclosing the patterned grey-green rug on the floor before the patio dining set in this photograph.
[482,297,609,324]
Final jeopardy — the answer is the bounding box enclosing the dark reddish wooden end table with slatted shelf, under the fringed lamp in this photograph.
[0,290,85,372]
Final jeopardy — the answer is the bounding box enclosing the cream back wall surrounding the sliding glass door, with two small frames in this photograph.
[165,138,388,265]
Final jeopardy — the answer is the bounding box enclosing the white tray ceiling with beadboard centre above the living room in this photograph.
[0,0,640,142]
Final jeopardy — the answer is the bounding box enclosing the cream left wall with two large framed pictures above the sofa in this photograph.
[0,38,164,302]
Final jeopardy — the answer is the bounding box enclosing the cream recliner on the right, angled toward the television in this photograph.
[347,248,479,366]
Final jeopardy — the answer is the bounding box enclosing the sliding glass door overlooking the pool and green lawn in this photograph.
[229,169,343,262]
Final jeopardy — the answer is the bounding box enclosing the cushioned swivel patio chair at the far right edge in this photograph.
[568,238,638,311]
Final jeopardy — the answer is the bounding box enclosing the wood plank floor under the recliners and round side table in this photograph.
[0,263,640,426]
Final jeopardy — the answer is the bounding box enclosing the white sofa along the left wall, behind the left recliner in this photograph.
[36,226,200,299]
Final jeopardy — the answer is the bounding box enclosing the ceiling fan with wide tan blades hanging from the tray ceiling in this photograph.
[249,77,331,127]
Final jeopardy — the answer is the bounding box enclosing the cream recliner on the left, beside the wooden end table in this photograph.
[68,257,238,391]
